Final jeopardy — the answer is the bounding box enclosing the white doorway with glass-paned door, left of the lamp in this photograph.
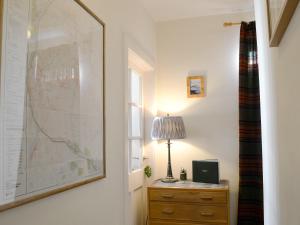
[124,37,156,225]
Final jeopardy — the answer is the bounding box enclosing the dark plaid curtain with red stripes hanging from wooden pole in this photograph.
[238,22,264,225]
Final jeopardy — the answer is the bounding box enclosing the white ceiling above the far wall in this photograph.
[138,0,254,21]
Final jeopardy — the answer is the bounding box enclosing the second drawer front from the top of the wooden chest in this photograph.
[150,202,227,223]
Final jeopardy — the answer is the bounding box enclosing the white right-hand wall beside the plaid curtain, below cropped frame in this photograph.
[255,0,300,225]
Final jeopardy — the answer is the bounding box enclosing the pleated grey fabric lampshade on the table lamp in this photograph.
[151,116,186,140]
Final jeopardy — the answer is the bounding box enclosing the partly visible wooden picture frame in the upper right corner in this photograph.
[266,0,299,47]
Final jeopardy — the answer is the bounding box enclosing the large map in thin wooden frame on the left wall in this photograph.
[0,0,105,211]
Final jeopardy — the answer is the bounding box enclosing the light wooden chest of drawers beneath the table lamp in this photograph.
[148,181,229,225]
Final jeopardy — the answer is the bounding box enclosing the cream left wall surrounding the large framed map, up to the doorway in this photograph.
[0,0,156,225]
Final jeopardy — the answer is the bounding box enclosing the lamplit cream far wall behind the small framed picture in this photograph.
[156,13,254,225]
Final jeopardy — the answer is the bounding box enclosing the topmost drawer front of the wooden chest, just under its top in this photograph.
[149,189,227,204]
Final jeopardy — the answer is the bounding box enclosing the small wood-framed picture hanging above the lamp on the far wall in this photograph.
[186,76,205,98]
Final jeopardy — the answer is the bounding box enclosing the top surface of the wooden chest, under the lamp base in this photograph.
[149,180,229,190]
